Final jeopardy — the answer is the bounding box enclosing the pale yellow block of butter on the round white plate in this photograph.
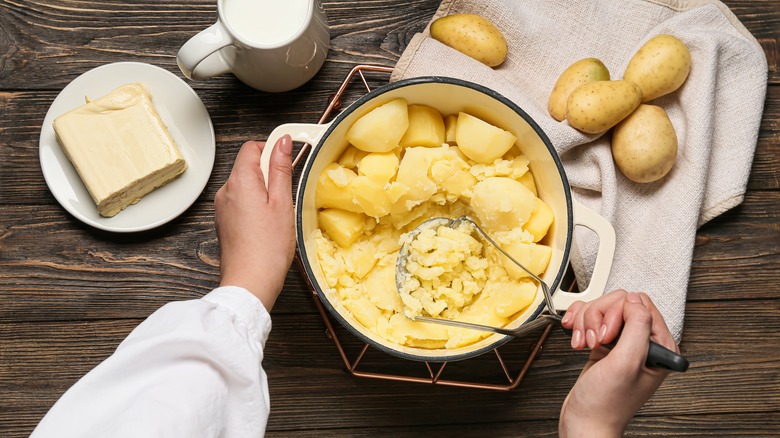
[54,83,187,217]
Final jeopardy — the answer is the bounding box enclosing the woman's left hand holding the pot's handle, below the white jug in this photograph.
[214,136,295,312]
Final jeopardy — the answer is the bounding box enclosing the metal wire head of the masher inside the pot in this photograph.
[395,216,561,337]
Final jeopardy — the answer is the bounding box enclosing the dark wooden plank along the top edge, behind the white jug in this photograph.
[0,0,430,91]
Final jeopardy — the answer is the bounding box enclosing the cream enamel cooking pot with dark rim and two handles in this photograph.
[261,77,615,362]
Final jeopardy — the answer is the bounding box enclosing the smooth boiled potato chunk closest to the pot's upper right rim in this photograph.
[455,112,517,164]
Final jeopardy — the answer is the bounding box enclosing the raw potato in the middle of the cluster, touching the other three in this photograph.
[566,80,642,134]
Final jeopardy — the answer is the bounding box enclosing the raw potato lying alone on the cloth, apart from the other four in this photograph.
[431,14,507,67]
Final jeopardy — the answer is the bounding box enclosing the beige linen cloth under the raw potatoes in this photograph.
[391,0,767,341]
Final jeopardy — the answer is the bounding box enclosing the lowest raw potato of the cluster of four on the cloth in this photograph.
[612,104,677,183]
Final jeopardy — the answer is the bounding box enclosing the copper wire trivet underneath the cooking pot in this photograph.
[293,65,576,391]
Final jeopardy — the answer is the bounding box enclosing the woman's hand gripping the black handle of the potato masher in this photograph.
[559,290,679,437]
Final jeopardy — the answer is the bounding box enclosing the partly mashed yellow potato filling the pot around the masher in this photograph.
[314,103,553,348]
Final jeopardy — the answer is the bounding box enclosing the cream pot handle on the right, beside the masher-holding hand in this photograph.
[553,199,615,310]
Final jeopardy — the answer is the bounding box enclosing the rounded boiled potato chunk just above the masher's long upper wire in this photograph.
[471,177,537,231]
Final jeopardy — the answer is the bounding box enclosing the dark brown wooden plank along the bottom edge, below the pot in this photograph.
[0,298,780,436]
